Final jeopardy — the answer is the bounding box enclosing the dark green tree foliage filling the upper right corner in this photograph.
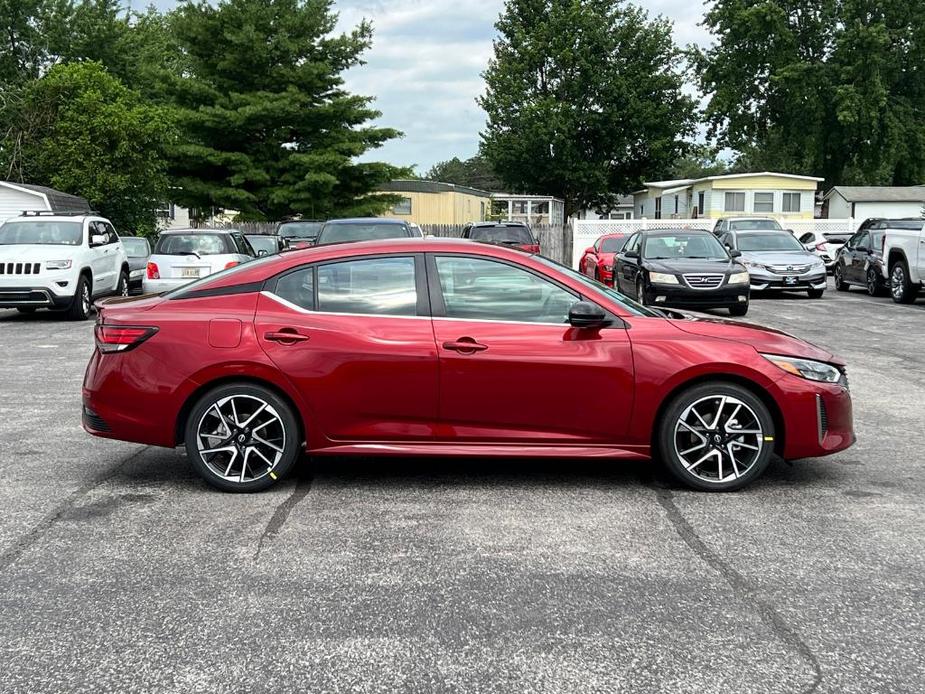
[694,0,925,185]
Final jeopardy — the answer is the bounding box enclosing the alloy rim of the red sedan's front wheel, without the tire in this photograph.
[674,395,764,484]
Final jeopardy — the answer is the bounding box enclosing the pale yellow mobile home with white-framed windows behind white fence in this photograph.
[633,171,823,220]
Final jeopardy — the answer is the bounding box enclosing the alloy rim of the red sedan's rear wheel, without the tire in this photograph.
[196,395,286,484]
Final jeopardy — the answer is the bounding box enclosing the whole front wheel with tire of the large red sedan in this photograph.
[658,382,774,492]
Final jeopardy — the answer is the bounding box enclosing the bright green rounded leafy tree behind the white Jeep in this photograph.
[11,62,174,233]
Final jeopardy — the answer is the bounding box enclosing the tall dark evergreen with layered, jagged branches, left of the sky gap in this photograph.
[171,0,408,220]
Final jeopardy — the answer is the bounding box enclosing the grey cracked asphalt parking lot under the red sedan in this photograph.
[0,283,925,694]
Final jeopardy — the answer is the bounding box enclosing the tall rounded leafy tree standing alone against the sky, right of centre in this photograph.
[479,0,694,215]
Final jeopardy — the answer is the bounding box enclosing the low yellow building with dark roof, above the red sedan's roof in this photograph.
[379,181,491,224]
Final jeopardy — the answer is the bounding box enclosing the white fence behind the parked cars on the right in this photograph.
[572,218,864,268]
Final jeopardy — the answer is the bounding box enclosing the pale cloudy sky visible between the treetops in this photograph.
[148,0,704,173]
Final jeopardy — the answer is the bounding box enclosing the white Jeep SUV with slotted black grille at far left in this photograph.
[0,212,129,320]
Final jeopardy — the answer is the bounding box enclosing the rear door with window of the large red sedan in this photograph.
[255,255,437,442]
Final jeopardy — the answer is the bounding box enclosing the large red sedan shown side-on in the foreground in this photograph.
[83,239,854,491]
